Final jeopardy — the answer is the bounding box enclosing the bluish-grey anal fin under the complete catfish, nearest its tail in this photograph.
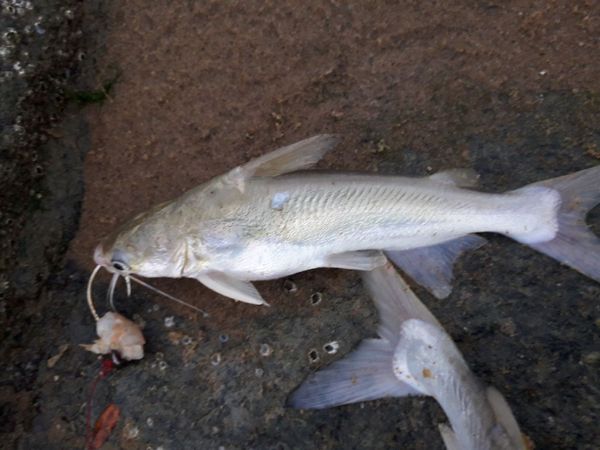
[386,234,486,298]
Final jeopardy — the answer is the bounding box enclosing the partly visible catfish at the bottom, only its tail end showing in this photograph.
[288,264,527,450]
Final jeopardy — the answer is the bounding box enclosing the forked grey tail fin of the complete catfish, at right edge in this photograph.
[519,166,600,282]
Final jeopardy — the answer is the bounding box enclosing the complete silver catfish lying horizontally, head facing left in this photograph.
[94,135,600,304]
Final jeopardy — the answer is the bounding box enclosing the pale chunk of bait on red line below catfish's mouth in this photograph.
[81,312,146,360]
